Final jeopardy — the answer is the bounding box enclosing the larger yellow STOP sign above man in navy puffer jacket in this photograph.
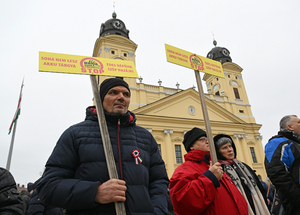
[39,52,139,78]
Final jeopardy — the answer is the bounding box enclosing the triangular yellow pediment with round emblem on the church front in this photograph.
[133,88,245,123]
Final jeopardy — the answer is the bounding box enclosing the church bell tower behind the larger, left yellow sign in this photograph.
[93,12,137,89]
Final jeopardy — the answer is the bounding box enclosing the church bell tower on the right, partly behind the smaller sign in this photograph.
[203,40,255,123]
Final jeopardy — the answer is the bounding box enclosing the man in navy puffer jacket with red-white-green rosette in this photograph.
[38,78,169,215]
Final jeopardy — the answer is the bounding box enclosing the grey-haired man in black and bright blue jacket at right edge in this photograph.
[265,115,300,215]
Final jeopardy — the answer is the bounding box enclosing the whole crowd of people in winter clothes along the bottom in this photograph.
[0,78,300,215]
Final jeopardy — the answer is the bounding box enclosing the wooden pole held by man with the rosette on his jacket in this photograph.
[90,75,126,215]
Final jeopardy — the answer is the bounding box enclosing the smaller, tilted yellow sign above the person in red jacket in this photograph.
[165,44,225,78]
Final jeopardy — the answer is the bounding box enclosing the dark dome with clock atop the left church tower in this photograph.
[100,12,129,39]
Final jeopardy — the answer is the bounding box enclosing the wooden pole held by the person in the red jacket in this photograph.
[194,70,218,164]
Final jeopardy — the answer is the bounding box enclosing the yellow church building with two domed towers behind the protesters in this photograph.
[93,13,266,179]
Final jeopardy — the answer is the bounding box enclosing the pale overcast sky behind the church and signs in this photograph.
[0,0,300,186]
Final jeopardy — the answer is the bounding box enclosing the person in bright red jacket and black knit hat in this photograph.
[170,127,248,215]
